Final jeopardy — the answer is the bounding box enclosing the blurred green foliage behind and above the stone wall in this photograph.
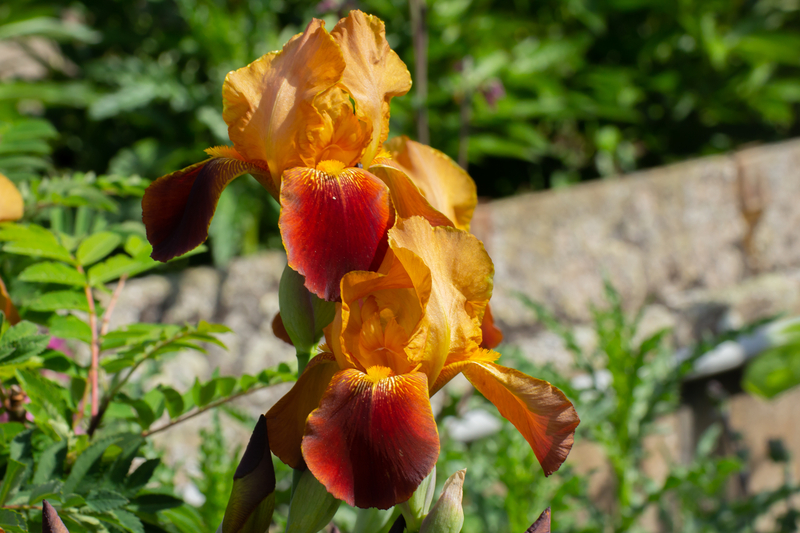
[0,0,800,264]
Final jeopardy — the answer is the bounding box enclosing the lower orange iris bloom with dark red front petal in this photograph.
[266,217,579,509]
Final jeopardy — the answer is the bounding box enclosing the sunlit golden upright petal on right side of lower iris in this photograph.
[389,217,494,383]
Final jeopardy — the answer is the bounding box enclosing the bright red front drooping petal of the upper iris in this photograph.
[278,168,394,301]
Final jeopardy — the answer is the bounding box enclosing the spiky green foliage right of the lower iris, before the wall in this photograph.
[437,286,800,533]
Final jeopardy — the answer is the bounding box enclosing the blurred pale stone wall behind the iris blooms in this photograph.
[114,140,800,508]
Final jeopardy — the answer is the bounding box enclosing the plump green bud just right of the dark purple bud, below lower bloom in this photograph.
[286,470,342,533]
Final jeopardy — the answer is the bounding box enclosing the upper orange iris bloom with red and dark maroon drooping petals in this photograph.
[142,11,462,300]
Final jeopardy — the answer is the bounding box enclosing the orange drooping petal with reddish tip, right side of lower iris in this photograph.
[457,360,580,476]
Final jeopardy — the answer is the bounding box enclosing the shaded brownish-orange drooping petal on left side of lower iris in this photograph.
[266,353,339,468]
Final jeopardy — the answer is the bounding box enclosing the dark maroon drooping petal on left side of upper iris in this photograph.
[142,154,258,261]
